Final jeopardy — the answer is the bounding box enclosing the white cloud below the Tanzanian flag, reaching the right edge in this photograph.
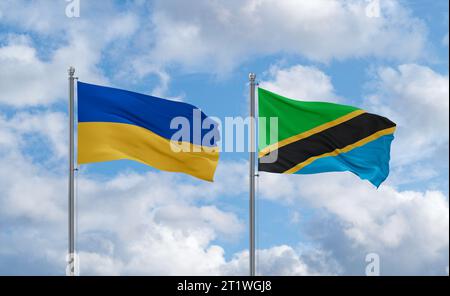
[260,173,449,274]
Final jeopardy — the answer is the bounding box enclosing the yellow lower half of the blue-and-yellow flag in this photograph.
[78,122,219,181]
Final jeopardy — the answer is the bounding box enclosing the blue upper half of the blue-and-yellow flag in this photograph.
[77,82,219,146]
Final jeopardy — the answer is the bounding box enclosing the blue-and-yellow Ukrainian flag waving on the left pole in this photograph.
[78,82,219,181]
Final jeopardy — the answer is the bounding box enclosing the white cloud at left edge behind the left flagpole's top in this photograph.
[0,33,105,107]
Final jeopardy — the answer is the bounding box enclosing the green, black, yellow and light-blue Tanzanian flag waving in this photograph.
[258,88,396,187]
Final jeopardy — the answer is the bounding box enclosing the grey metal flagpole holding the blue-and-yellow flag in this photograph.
[67,67,76,276]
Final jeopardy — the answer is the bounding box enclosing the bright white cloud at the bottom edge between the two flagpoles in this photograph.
[80,219,229,275]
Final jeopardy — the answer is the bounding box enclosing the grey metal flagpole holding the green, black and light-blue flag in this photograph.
[249,73,256,276]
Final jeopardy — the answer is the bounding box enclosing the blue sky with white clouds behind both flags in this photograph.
[0,0,449,275]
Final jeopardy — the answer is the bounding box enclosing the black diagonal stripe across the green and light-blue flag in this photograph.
[258,113,395,173]
